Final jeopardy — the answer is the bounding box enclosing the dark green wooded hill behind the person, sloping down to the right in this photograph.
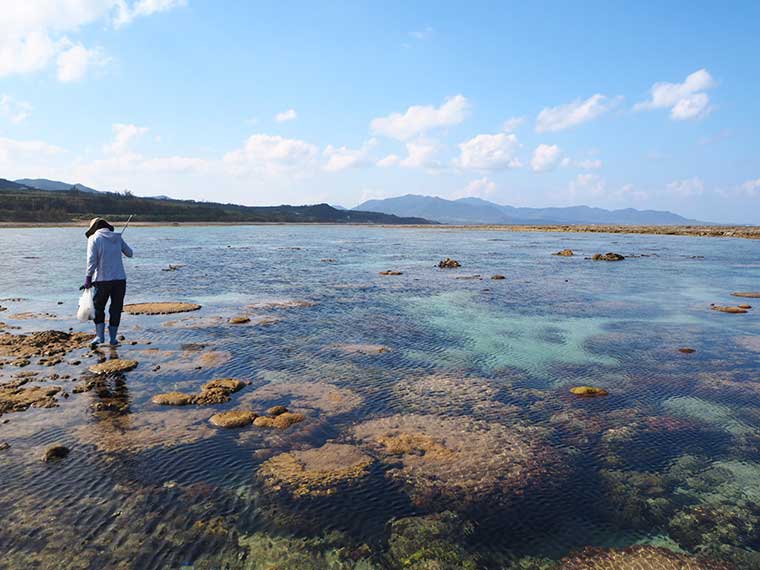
[0,184,430,224]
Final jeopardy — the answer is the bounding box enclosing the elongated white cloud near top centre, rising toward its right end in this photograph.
[370,95,469,141]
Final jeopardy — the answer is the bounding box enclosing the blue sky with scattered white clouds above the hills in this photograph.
[0,0,760,224]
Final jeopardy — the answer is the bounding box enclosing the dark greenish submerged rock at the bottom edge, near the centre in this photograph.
[388,511,479,570]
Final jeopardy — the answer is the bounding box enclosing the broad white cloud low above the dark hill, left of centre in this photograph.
[223,134,319,175]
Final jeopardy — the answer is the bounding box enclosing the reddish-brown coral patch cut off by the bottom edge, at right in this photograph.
[560,545,738,570]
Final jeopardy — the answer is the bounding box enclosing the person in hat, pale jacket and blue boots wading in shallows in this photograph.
[84,218,132,346]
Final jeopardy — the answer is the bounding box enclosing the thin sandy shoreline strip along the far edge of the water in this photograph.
[0,222,760,239]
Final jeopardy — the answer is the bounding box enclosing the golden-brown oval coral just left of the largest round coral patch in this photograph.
[257,442,372,497]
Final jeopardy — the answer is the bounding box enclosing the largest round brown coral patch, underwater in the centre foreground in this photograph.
[354,415,565,509]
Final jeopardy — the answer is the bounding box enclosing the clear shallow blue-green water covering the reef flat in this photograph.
[0,226,760,569]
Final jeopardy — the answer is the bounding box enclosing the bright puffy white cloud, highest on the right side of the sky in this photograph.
[633,69,717,121]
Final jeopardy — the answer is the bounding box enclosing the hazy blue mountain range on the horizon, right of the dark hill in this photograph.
[355,194,704,226]
